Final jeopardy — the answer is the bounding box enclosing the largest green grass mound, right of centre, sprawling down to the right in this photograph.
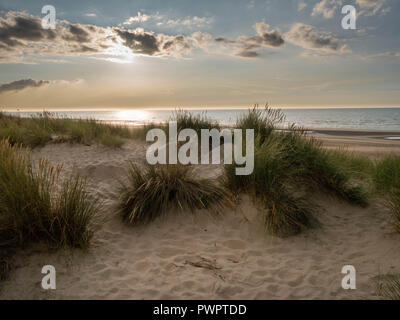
[225,106,371,236]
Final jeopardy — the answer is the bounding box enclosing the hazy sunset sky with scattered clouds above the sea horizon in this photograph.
[0,0,400,110]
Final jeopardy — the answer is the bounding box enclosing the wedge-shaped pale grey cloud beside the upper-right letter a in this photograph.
[285,23,349,53]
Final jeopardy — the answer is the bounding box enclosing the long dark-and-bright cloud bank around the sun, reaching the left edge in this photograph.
[0,12,197,63]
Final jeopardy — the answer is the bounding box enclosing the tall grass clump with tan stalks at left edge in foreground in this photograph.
[0,140,98,278]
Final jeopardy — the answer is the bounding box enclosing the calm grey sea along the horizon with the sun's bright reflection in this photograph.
[3,108,400,131]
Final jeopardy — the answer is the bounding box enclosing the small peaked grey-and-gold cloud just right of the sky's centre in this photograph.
[214,22,285,58]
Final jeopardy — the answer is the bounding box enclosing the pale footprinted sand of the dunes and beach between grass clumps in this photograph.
[0,134,400,299]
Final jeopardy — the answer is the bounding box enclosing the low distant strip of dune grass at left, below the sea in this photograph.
[0,112,132,147]
